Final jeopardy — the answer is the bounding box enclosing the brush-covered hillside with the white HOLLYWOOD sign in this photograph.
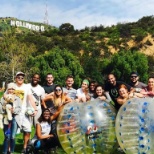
[0,16,154,85]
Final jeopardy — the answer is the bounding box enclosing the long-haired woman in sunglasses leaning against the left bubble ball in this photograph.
[42,85,72,120]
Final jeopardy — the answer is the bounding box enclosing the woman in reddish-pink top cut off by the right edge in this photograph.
[140,77,154,97]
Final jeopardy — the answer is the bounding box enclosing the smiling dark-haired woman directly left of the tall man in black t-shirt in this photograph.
[94,85,107,101]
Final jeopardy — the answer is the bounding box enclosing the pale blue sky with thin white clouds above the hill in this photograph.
[0,0,154,29]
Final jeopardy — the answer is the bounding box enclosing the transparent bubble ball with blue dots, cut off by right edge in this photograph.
[116,98,154,154]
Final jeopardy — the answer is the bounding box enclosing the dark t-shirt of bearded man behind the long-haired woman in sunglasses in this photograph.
[43,84,56,108]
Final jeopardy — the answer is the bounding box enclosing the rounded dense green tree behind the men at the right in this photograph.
[102,51,148,82]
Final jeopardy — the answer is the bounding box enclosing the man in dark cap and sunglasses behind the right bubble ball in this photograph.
[130,72,147,92]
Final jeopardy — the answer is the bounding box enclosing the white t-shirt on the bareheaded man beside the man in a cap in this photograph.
[27,83,45,109]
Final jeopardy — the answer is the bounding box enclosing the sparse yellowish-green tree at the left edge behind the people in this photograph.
[0,31,35,82]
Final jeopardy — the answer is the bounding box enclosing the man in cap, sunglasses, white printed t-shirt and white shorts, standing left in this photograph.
[15,72,37,154]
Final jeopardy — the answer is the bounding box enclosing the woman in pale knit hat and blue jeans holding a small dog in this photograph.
[1,83,21,154]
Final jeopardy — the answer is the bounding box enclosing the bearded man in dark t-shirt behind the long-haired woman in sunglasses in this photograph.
[43,73,56,108]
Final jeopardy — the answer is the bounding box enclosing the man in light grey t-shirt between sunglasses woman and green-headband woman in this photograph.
[63,75,76,100]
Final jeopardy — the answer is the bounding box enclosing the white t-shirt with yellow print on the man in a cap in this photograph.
[15,83,32,114]
